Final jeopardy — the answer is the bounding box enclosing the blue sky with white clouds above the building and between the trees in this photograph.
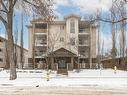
[0,0,111,52]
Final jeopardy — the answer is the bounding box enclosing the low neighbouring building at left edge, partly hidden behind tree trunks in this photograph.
[0,37,28,68]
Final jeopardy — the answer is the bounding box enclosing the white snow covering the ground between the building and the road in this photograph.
[0,69,127,88]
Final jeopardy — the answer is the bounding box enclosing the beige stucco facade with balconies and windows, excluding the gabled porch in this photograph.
[28,15,96,70]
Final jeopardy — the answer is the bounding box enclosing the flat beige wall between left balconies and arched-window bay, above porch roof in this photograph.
[48,25,66,52]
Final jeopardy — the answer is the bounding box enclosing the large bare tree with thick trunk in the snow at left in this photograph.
[0,0,52,80]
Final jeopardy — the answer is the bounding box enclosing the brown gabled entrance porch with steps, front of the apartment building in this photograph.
[49,48,77,74]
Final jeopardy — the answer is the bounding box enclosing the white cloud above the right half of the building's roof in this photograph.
[72,0,111,13]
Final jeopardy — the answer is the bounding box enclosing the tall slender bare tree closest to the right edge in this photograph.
[111,0,127,66]
